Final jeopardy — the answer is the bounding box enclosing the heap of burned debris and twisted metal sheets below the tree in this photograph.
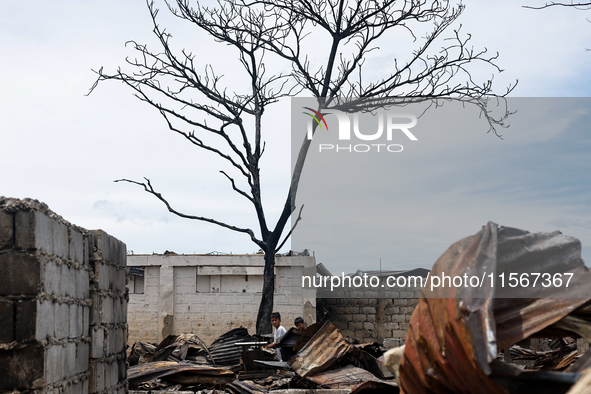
[128,322,398,394]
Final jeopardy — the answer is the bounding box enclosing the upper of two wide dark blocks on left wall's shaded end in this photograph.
[0,253,41,295]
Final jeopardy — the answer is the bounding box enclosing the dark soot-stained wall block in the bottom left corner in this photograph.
[0,345,45,392]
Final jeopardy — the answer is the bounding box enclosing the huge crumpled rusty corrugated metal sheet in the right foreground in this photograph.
[400,223,591,394]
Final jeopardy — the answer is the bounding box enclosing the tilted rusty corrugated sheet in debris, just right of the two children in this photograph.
[289,321,354,378]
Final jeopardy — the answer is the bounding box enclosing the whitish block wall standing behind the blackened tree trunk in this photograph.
[128,255,316,345]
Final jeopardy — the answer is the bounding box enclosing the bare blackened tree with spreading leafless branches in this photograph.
[91,0,512,334]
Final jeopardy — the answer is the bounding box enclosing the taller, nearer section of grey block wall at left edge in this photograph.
[0,196,126,394]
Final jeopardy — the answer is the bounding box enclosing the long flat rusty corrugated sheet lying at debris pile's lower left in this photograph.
[127,361,236,386]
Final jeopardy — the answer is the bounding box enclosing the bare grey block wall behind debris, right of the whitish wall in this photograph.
[317,287,420,349]
